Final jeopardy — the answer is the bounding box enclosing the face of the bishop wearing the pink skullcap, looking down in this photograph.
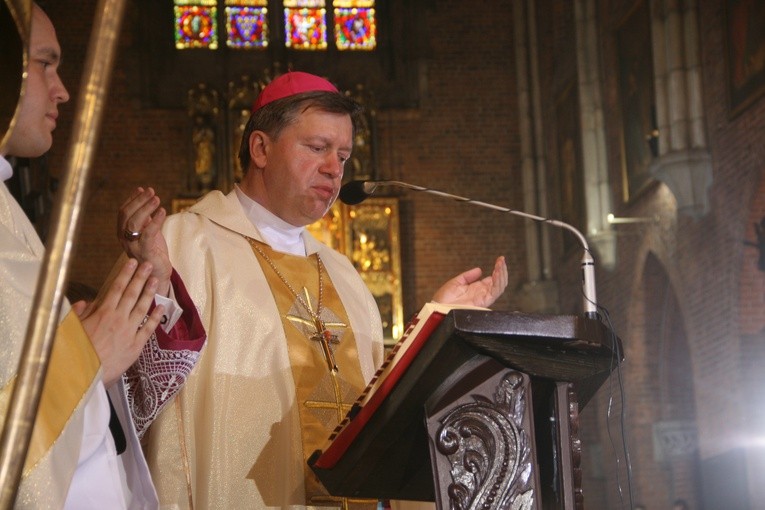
[253,108,353,226]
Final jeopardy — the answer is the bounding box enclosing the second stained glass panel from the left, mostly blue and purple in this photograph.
[226,0,268,48]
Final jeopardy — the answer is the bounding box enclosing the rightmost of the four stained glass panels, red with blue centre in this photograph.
[332,0,377,50]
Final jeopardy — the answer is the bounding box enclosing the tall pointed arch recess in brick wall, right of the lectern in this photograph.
[625,253,699,508]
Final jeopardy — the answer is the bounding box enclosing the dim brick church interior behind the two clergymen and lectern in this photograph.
[0,0,765,510]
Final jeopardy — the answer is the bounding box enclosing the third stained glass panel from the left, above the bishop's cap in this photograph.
[284,0,327,50]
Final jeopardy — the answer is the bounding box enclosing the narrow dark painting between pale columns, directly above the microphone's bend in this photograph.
[555,83,586,250]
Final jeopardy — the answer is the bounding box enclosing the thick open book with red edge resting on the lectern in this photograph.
[309,302,488,469]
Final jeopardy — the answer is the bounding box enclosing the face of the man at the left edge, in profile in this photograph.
[5,5,69,158]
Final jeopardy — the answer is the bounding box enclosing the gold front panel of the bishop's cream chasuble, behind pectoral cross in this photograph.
[248,238,376,509]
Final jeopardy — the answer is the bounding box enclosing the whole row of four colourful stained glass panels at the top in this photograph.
[173,0,377,51]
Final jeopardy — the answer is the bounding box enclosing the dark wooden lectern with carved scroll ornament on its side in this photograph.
[309,309,622,510]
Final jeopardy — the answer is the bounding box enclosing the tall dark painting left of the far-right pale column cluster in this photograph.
[616,1,658,202]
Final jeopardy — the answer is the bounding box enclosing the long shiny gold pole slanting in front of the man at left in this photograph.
[0,0,125,509]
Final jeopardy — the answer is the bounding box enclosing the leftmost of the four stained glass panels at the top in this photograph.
[175,0,218,50]
